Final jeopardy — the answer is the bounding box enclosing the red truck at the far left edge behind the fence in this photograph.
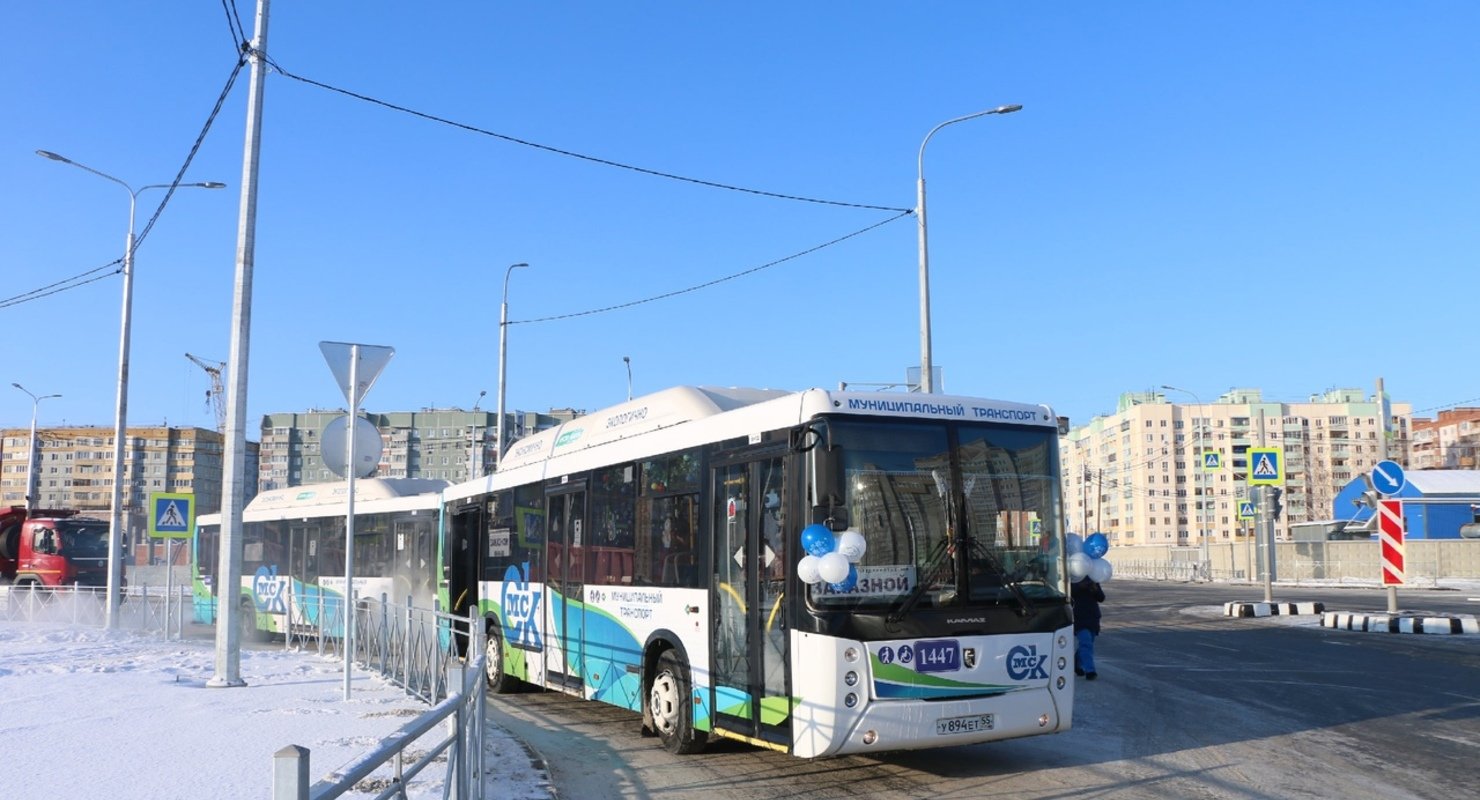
[0,506,108,587]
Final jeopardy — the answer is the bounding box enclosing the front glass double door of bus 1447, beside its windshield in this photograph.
[710,451,792,748]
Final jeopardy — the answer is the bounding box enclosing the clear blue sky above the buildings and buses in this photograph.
[0,0,1480,438]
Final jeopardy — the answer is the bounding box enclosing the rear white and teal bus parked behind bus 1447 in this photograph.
[191,478,447,639]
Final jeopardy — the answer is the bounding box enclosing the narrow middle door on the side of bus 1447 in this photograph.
[545,487,588,692]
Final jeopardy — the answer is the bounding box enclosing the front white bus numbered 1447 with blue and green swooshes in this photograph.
[438,387,1073,757]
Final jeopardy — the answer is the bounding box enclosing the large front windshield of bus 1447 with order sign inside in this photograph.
[813,418,1066,614]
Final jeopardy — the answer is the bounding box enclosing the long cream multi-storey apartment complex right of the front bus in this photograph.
[1060,389,1412,546]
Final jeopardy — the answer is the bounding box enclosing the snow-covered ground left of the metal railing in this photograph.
[0,623,549,800]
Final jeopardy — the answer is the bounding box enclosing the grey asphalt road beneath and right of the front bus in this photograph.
[490,580,1480,800]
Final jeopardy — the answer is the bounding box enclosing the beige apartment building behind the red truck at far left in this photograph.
[0,426,258,563]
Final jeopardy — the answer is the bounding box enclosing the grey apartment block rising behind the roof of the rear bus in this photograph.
[258,408,585,491]
